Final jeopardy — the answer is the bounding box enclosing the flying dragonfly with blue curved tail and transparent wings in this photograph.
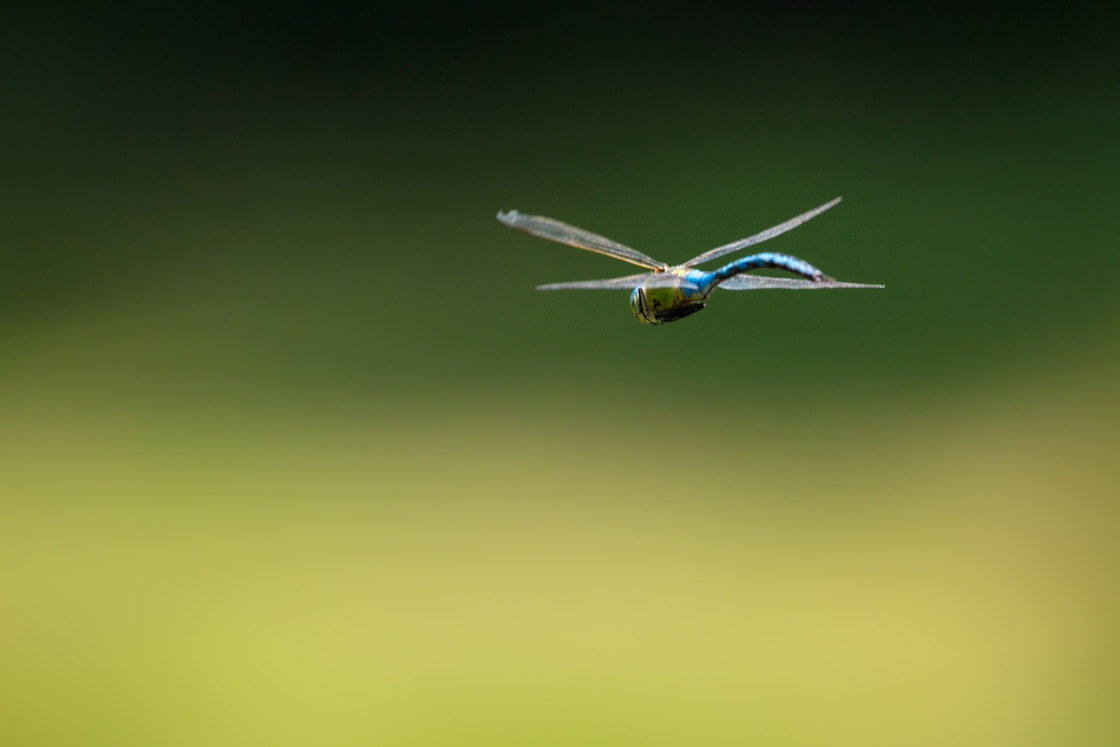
[497,197,883,325]
